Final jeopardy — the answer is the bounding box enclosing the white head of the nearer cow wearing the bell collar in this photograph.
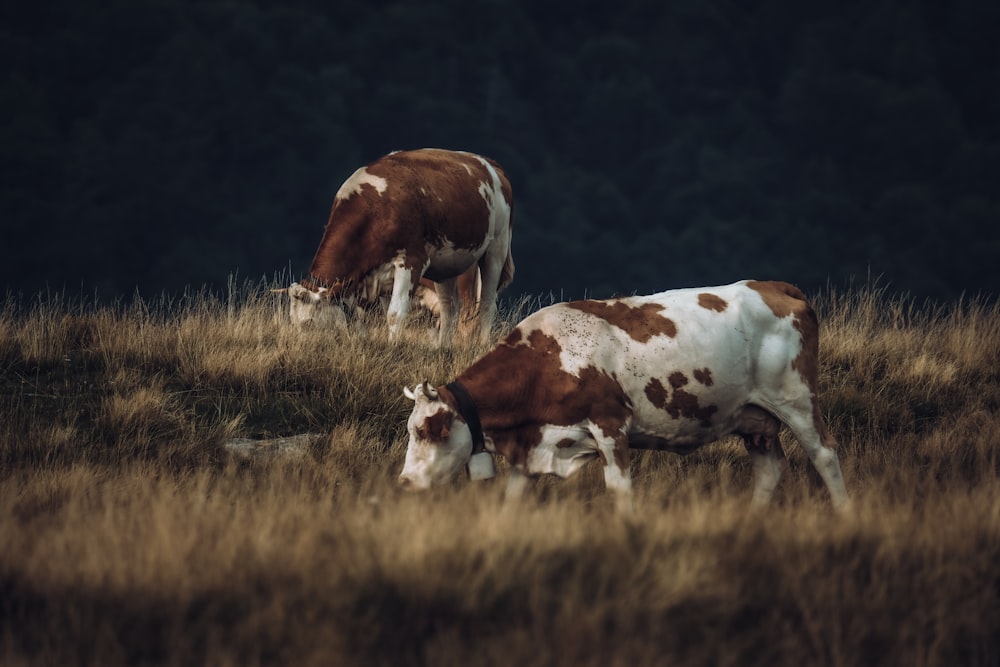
[399,381,472,490]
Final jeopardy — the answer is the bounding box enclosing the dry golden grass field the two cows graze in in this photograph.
[0,286,1000,667]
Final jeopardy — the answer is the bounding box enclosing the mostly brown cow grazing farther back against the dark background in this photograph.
[288,148,514,345]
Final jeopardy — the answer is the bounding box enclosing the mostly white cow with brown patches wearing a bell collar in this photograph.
[399,280,848,512]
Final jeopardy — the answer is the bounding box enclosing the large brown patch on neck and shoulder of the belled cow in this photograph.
[458,329,632,466]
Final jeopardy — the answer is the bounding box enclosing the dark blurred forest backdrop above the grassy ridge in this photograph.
[0,0,1000,299]
